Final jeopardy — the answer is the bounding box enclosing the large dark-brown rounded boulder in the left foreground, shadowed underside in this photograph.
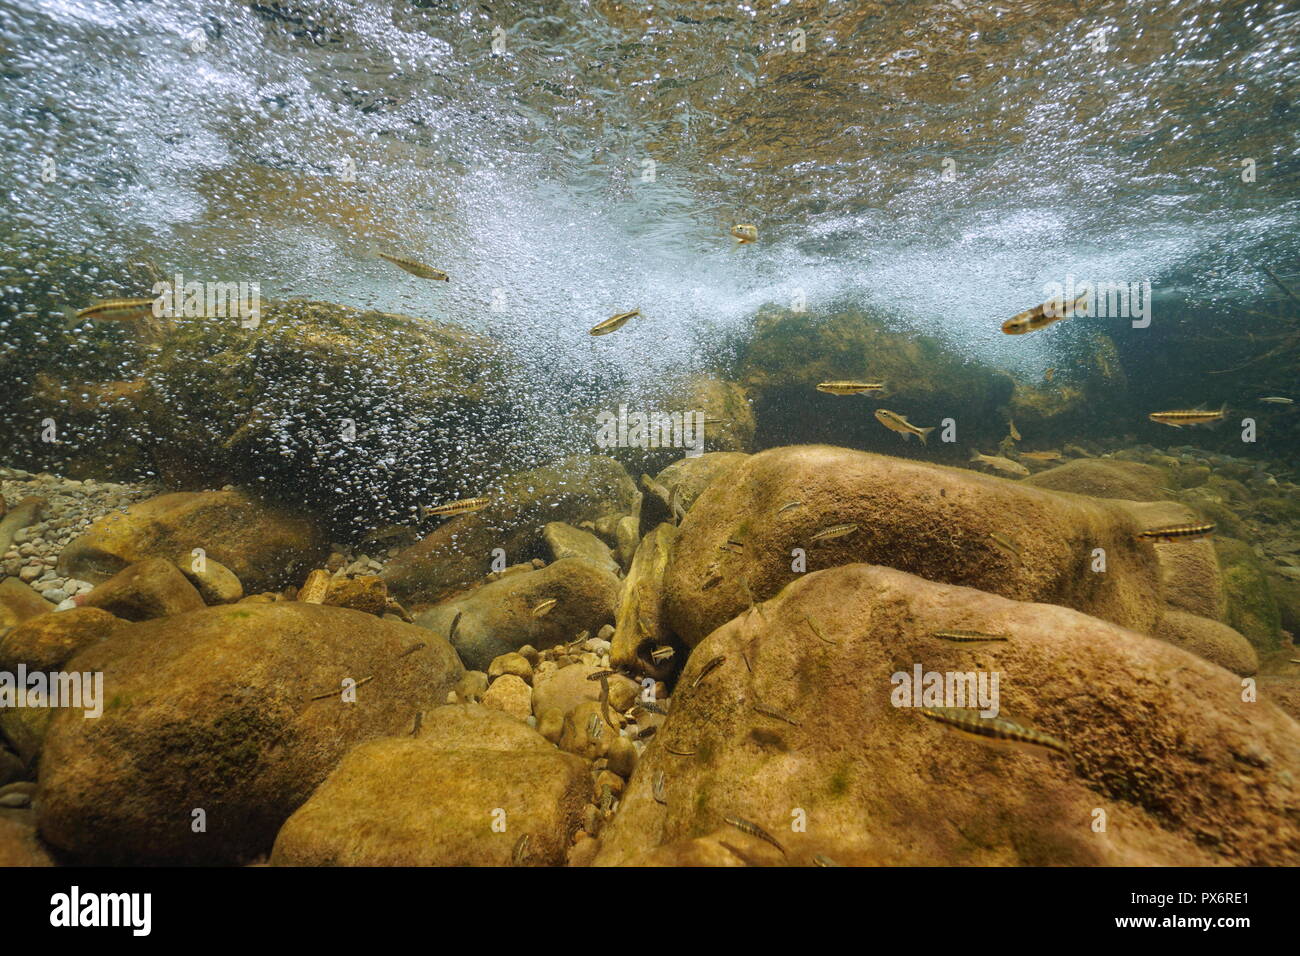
[38,602,463,864]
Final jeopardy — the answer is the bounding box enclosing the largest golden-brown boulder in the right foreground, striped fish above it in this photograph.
[595,564,1300,866]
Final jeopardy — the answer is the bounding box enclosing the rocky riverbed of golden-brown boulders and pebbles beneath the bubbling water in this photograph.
[0,444,1300,865]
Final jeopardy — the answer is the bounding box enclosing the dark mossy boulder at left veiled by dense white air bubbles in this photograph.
[133,300,512,530]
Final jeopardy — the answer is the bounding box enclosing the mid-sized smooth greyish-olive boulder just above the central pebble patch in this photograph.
[416,558,619,670]
